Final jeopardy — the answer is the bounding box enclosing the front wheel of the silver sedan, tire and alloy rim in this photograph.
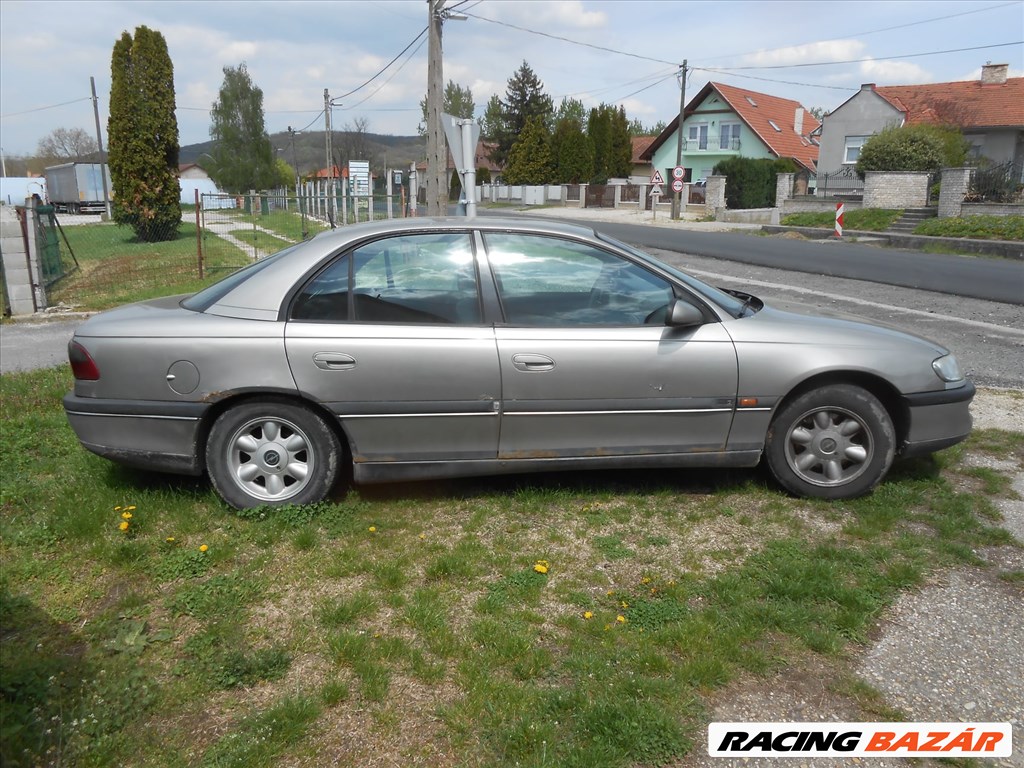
[765,384,896,499]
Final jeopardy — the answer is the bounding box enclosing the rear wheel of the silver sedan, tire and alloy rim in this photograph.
[206,399,342,509]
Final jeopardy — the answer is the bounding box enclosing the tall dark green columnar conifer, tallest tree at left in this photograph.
[106,27,181,243]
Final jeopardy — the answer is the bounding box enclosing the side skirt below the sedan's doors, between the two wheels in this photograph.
[352,449,761,485]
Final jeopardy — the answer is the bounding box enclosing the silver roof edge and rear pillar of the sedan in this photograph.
[205,216,595,321]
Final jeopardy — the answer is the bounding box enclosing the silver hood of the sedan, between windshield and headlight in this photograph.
[729,302,949,356]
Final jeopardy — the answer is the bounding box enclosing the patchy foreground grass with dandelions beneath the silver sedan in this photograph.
[0,368,1024,767]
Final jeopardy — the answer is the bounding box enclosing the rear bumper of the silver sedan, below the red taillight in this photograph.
[63,393,209,475]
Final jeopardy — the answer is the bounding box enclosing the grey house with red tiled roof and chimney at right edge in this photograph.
[818,65,1024,171]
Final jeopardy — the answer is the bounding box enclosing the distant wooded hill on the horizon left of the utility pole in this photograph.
[178,131,426,180]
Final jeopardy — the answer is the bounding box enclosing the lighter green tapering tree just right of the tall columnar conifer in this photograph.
[207,61,280,195]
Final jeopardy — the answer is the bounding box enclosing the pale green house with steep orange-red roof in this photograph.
[640,83,819,181]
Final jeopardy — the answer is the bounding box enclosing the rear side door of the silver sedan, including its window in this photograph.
[285,232,501,463]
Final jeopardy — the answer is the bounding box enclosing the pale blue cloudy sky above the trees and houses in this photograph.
[0,0,1024,157]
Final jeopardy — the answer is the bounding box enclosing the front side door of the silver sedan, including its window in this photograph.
[484,232,737,460]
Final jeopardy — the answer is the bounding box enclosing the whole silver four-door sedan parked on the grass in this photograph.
[65,218,974,507]
